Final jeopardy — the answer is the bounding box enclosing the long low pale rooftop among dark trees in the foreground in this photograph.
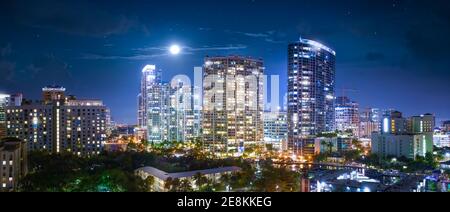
[137,166,241,181]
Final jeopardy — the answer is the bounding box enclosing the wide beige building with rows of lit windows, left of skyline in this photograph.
[6,87,108,156]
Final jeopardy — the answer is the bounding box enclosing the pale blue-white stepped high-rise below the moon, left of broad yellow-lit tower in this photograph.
[137,65,201,143]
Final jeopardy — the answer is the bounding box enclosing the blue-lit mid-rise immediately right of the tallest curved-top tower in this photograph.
[335,96,360,137]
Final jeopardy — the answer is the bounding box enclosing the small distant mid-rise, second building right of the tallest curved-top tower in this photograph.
[359,108,380,138]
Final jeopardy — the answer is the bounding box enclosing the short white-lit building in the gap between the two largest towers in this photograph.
[264,111,288,151]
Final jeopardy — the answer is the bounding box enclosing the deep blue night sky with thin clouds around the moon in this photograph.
[0,0,450,124]
